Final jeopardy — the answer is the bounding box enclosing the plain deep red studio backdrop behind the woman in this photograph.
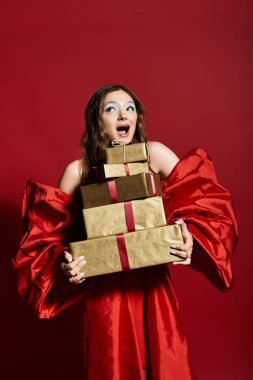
[0,0,253,380]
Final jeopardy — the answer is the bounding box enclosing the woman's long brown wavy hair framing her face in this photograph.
[81,84,147,185]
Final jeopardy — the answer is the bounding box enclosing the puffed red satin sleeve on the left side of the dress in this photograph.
[13,181,95,318]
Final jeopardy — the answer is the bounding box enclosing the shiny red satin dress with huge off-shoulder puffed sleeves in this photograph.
[13,148,237,380]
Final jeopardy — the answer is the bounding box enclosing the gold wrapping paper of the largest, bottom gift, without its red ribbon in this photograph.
[70,224,183,277]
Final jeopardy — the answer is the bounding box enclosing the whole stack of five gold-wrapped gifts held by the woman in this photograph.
[70,143,183,277]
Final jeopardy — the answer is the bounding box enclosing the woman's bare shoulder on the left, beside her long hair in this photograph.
[58,160,82,195]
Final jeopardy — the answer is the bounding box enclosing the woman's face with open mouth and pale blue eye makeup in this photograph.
[101,90,137,144]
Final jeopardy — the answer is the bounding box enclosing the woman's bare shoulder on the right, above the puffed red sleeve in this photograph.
[148,141,179,178]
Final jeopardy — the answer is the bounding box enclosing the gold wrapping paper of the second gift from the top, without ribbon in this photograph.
[92,162,150,182]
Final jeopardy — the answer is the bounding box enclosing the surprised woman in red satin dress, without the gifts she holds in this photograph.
[14,85,237,380]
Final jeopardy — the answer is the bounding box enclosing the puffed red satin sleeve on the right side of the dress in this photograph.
[163,148,237,290]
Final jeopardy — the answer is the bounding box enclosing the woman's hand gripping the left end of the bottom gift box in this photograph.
[61,251,86,285]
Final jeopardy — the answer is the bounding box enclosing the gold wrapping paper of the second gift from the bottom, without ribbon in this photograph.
[83,196,166,239]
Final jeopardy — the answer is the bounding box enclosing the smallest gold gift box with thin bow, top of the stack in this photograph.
[105,143,148,164]
